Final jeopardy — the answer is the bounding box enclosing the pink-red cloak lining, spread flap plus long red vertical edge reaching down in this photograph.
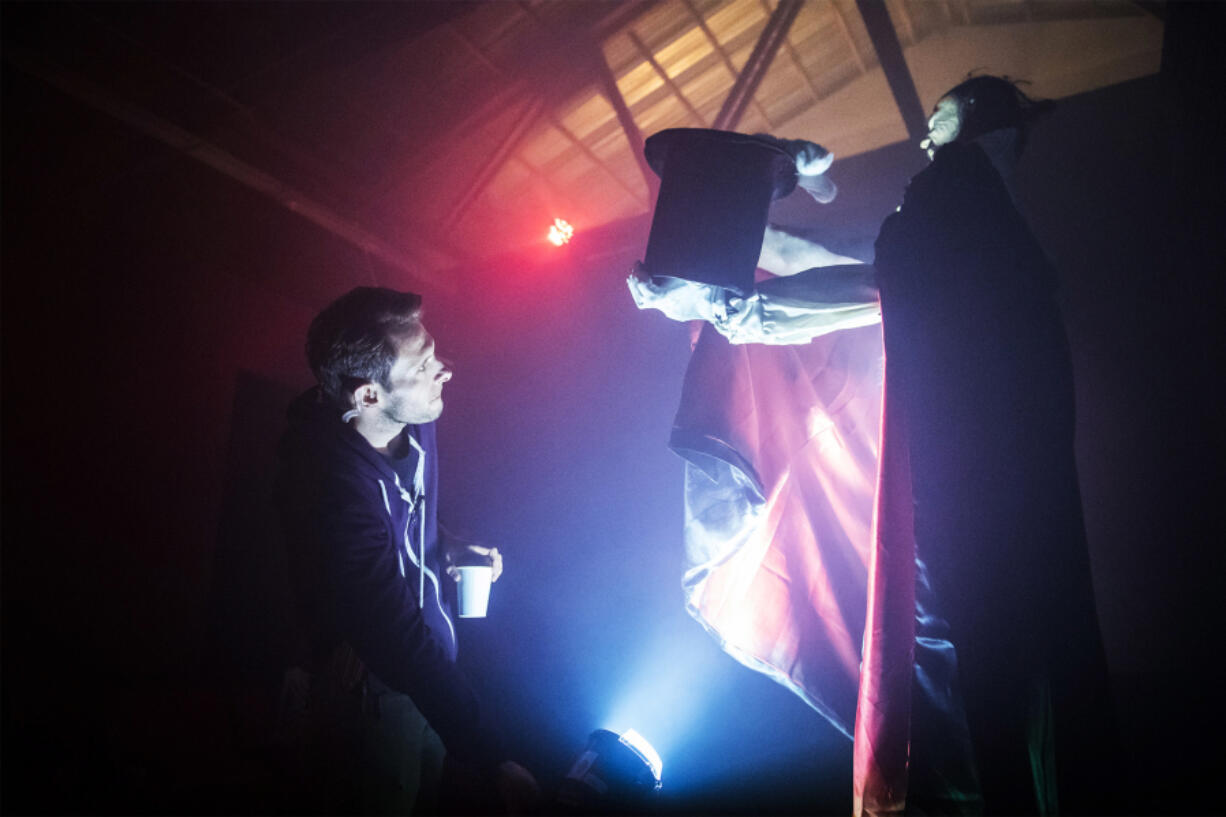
[671,312,977,815]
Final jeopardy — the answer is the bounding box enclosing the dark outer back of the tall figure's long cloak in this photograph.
[875,142,1118,813]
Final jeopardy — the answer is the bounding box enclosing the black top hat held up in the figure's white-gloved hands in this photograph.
[644,128,797,296]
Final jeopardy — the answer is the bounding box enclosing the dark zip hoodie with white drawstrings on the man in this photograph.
[278,389,503,768]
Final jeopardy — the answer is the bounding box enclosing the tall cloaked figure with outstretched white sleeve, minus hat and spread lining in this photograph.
[630,76,1117,813]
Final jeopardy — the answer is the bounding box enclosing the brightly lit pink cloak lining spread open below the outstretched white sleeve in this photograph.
[671,325,882,737]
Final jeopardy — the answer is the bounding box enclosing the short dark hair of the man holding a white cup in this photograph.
[307,287,422,406]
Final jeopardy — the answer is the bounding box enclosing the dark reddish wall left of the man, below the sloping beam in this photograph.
[4,55,345,811]
